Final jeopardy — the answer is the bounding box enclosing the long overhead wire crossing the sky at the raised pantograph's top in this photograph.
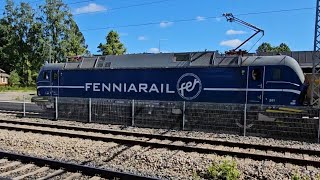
[81,7,315,32]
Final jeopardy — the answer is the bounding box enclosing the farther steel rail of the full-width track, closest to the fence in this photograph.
[0,119,320,156]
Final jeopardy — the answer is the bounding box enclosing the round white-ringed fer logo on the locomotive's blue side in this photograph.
[177,73,202,100]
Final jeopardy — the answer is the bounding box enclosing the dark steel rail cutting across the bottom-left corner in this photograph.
[0,151,154,180]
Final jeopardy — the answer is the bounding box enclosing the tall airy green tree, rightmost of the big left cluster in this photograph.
[41,0,87,62]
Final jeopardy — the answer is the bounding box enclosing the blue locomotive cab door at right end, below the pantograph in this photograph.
[247,66,265,104]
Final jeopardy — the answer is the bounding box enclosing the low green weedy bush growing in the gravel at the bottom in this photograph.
[208,161,240,180]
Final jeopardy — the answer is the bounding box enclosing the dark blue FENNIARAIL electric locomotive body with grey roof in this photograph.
[37,52,307,106]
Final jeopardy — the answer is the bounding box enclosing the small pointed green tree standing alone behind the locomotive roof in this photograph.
[98,30,127,55]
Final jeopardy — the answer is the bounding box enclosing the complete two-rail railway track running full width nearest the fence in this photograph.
[0,120,320,167]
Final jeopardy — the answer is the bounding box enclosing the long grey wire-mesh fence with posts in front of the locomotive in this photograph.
[0,98,320,142]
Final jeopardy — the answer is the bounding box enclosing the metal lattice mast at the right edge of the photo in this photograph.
[310,0,320,107]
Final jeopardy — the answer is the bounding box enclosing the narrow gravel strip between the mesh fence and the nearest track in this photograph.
[0,113,320,151]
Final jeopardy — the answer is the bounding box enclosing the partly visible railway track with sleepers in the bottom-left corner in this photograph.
[0,151,152,180]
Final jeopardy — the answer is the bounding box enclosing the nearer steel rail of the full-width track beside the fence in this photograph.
[0,121,320,168]
